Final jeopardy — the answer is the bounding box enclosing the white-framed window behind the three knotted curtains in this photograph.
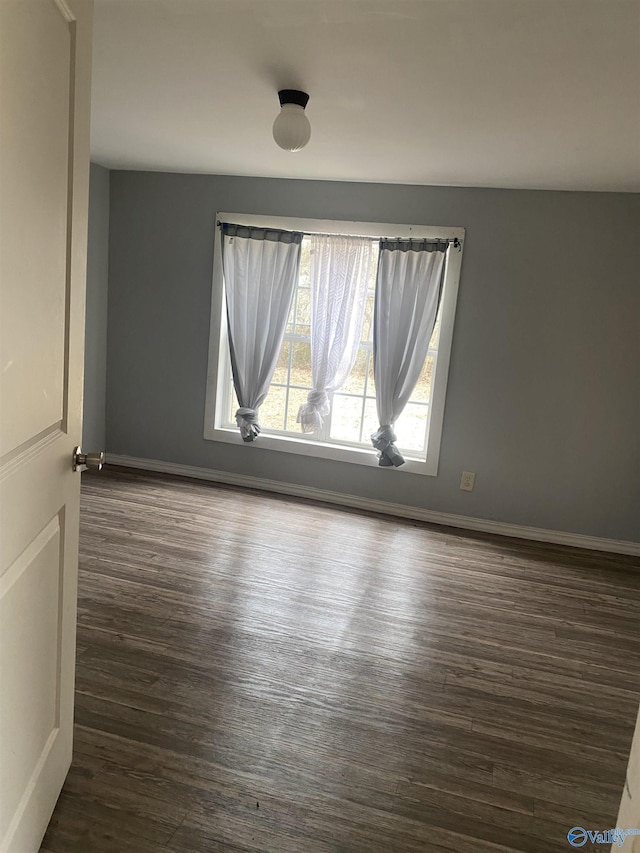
[205,213,464,474]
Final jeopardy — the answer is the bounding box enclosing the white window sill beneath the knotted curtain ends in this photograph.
[204,428,438,477]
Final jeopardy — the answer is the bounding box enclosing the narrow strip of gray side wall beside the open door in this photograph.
[82,163,109,451]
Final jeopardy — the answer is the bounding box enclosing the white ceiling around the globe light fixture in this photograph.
[92,0,640,192]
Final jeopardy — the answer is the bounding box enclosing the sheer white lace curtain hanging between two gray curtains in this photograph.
[297,234,375,433]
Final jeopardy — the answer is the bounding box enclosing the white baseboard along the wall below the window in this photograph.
[107,453,640,557]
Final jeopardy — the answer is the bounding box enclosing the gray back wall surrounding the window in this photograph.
[107,172,640,541]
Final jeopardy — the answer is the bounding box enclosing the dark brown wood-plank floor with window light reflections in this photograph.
[42,471,640,853]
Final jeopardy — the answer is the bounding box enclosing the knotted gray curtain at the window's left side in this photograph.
[222,222,302,441]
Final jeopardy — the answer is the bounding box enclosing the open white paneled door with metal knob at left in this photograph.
[0,0,92,853]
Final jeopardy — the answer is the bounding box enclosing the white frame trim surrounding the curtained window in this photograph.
[204,212,466,476]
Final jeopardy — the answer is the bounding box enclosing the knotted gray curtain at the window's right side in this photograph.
[371,240,449,467]
